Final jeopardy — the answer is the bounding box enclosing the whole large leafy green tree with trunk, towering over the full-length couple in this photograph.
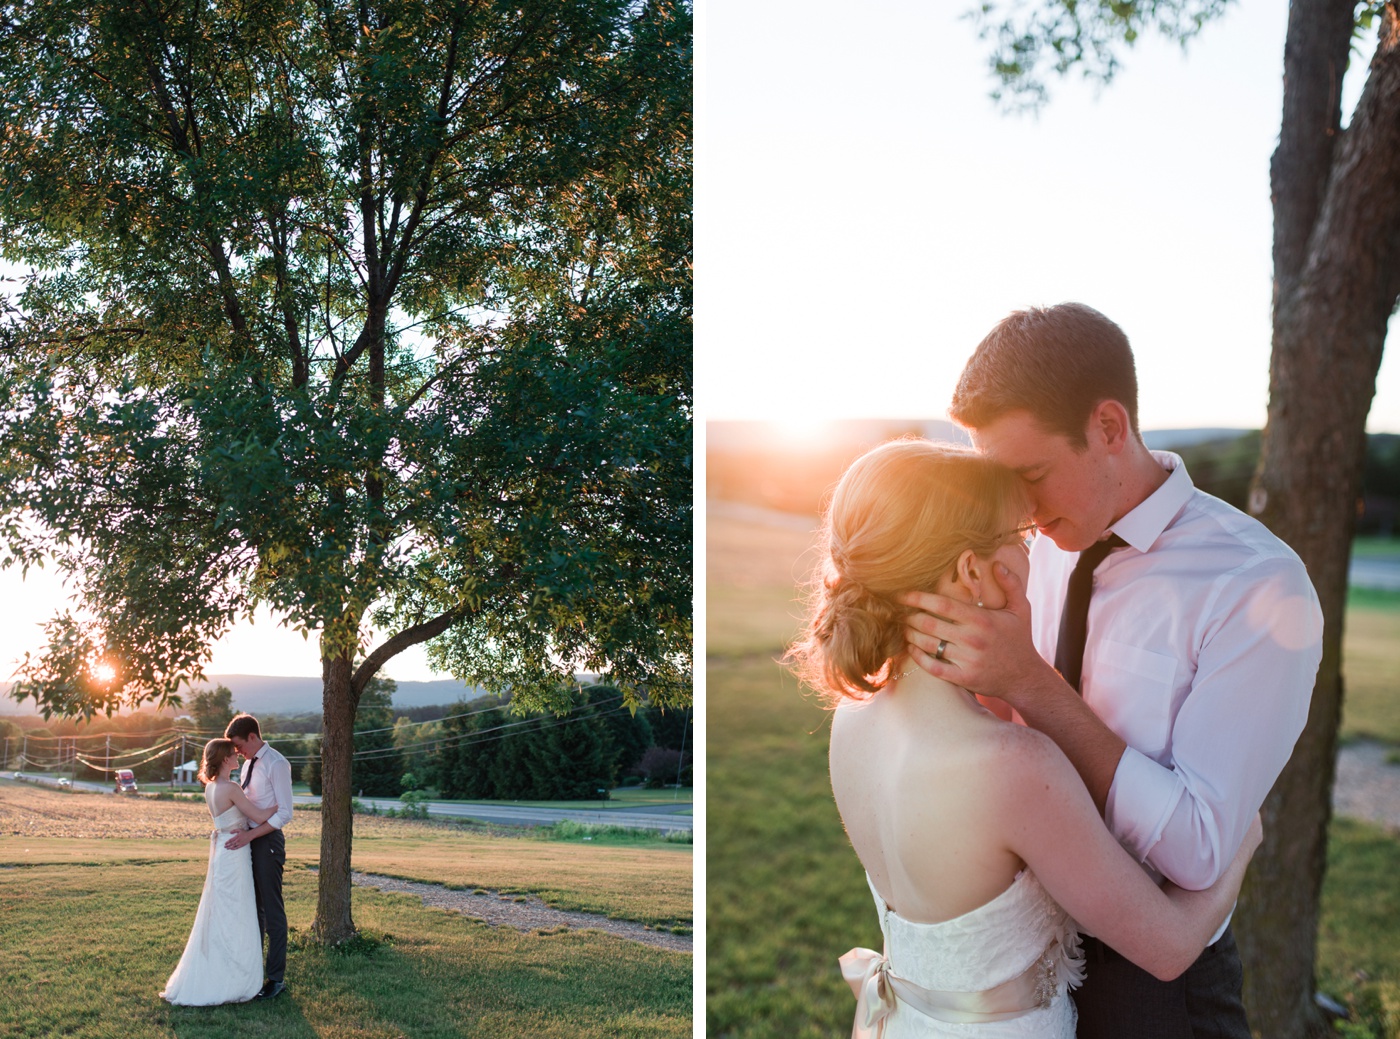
[0,0,692,941]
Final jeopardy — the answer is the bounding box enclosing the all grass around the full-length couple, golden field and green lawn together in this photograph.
[0,781,693,1039]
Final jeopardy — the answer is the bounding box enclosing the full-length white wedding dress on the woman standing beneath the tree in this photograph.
[161,783,263,1007]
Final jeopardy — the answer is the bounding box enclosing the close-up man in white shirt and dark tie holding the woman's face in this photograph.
[904,304,1322,1039]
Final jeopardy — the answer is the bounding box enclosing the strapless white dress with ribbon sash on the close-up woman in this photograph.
[841,870,1084,1039]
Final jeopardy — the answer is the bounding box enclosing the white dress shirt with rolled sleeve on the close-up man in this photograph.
[1028,451,1322,901]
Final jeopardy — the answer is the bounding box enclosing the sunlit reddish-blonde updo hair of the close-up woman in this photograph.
[787,438,1028,707]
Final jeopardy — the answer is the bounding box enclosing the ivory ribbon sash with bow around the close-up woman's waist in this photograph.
[840,938,1060,1039]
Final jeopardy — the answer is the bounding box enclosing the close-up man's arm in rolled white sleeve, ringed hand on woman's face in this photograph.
[903,557,1322,891]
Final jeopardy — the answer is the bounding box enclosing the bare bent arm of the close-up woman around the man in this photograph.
[997,730,1261,980]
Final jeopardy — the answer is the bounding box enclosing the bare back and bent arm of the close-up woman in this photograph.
[832,672,1259,979]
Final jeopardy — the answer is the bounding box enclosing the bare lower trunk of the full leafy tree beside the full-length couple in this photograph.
[311,653,358,945]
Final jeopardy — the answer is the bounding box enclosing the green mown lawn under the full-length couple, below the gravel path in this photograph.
[0,862,692,1039]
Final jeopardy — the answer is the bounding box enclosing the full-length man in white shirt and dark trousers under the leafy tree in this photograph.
[224,714,291,1000]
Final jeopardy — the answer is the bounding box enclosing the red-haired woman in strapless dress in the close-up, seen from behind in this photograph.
[788,440,1261,1039]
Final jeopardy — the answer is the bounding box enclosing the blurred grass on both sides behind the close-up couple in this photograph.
[706,515,1400,1039]
